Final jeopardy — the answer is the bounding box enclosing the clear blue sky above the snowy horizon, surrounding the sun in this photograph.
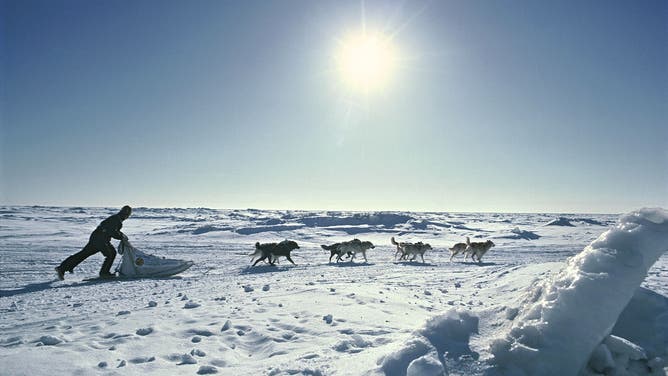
[0,0,668,213]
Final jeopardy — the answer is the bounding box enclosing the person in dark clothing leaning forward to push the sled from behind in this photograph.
[56,205,132,281]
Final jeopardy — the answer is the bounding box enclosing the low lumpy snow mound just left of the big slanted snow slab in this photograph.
[378,310,478,376]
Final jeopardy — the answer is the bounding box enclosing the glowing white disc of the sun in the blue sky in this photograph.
[335,32,397,93]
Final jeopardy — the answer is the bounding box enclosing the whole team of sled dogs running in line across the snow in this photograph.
[249,236,494,266]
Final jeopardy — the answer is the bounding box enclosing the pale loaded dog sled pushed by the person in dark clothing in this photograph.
[116,240,195,278]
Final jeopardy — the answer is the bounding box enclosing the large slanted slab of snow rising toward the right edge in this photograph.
[490,209,668,375]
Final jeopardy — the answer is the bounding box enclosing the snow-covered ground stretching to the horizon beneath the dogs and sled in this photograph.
[0,207,668,376]
